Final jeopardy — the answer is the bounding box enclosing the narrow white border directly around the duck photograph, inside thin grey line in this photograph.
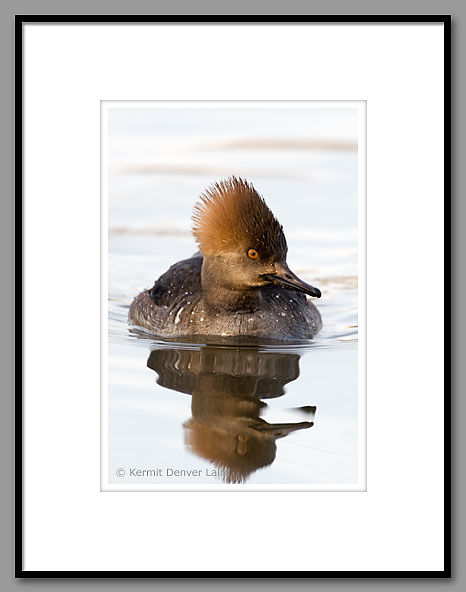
[100,101,366,492]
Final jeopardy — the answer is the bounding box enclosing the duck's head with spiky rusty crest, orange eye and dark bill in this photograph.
[193,177,321,298]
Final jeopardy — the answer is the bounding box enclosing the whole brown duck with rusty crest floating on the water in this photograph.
[129,177,322,340]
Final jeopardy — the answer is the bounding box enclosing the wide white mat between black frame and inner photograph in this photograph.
[23,23,444,572]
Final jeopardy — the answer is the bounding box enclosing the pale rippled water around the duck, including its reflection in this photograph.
[104,109,365,489]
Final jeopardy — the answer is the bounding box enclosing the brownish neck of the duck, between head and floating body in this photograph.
[201,258,262,312]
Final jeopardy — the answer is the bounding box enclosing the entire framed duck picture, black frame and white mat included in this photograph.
[15,15,450,577]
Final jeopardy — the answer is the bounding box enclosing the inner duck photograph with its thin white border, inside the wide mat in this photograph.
[101,101,366,491]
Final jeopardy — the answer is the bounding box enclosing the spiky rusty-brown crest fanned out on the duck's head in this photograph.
[193,177,287,257]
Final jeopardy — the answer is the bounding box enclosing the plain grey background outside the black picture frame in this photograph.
[0,0,458,592]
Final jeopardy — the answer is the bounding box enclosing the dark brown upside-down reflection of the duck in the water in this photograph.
[147,345,315,483]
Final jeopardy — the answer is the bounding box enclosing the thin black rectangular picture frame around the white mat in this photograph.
[15,15,452,579]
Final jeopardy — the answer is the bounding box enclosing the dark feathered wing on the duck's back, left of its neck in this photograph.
[149,253,202,306]
